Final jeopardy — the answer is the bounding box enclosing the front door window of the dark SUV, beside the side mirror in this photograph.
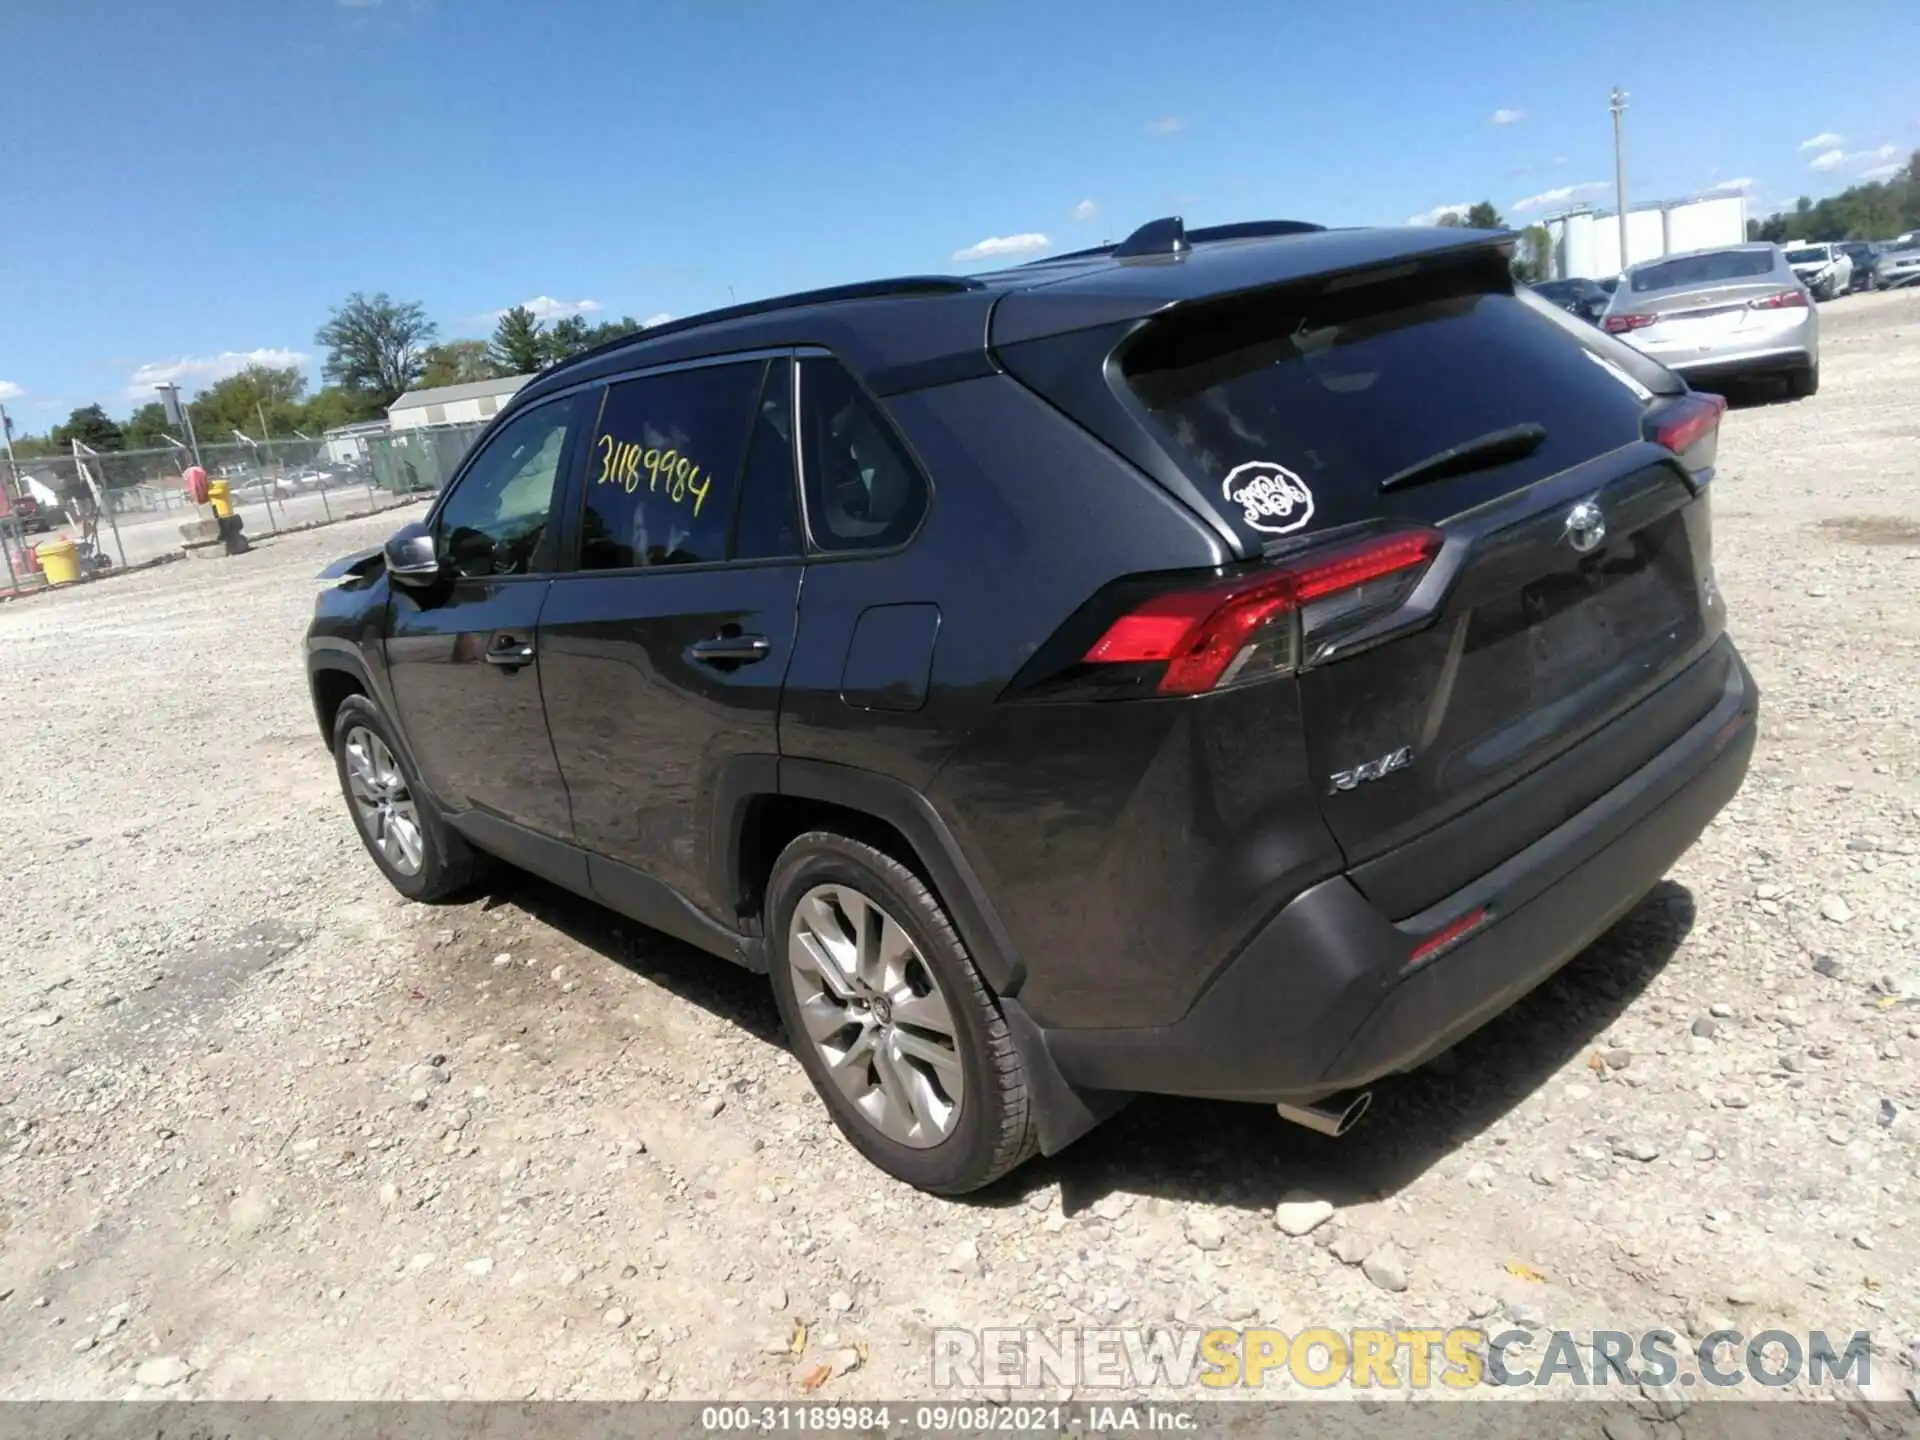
[434,397,580,580]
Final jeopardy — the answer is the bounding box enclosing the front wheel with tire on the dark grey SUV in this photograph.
[334,695,480,902]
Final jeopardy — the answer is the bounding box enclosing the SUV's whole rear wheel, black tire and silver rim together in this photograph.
[766,831,1037,1194]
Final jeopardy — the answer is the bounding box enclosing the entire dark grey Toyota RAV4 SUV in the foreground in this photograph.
[307,219,1757,1192]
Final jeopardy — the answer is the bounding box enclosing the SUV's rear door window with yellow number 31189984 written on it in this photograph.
[580,361,768,570]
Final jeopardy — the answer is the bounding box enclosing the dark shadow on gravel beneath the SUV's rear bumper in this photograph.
[979,881,1693,1215]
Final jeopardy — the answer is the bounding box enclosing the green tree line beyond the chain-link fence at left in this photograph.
[13,292,643,459]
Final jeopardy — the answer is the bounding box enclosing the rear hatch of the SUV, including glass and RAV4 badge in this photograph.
[1016,237,1720,918]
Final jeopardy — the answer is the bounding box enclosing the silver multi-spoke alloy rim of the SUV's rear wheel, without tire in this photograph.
[787,885,966,1150]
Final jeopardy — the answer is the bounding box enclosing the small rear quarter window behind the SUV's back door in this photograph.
[801,357,927,551]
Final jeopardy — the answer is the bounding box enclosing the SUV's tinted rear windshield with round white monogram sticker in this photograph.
[1121,264,1678,536]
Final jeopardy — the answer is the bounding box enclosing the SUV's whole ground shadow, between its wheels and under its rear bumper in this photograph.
[488,872,1693,1215]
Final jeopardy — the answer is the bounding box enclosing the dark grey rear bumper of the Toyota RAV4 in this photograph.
[1037,641,1759,1102]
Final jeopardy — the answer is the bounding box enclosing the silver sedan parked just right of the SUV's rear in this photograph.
[1601,242,1820,396]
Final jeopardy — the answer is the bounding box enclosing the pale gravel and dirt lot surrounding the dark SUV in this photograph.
[0,292,1920,1432]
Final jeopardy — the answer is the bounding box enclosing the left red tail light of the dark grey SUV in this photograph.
[1081,530,1440,695]
